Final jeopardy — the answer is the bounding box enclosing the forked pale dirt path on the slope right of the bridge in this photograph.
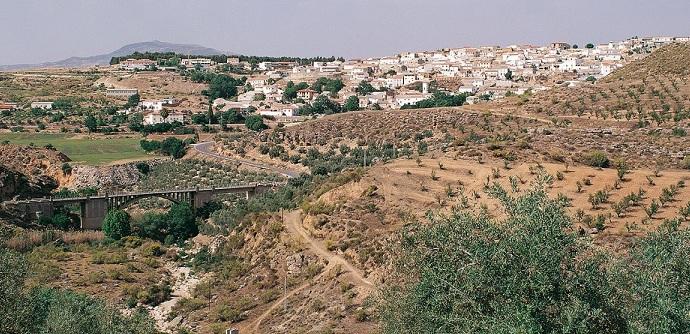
[250,210,374,333]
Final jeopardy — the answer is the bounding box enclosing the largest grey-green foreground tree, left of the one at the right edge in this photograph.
[380,186,625,333]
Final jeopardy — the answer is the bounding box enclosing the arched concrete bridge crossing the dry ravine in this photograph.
[8,183,280,229]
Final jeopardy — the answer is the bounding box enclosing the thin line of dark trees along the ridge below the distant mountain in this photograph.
[110,52,345,65]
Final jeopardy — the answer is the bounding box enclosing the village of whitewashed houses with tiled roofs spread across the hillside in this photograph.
[0,37,690,125]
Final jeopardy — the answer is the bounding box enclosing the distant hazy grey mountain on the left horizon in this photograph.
[0,41,234,71]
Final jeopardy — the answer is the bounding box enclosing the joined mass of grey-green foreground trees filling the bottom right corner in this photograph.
[380,186,690,333]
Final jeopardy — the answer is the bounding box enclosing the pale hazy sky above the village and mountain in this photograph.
[0,0,690,64]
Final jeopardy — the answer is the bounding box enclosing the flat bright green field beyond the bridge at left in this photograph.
[0,132,159,165]
